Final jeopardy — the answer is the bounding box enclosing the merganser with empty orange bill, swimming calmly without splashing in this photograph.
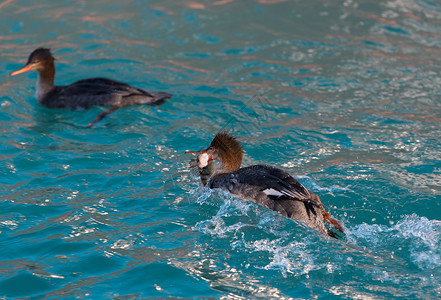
[11,48,171,127]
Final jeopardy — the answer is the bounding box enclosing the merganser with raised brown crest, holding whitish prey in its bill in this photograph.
[186,132,343,238]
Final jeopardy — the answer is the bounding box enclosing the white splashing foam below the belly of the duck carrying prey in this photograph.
[193,190,332,277]
